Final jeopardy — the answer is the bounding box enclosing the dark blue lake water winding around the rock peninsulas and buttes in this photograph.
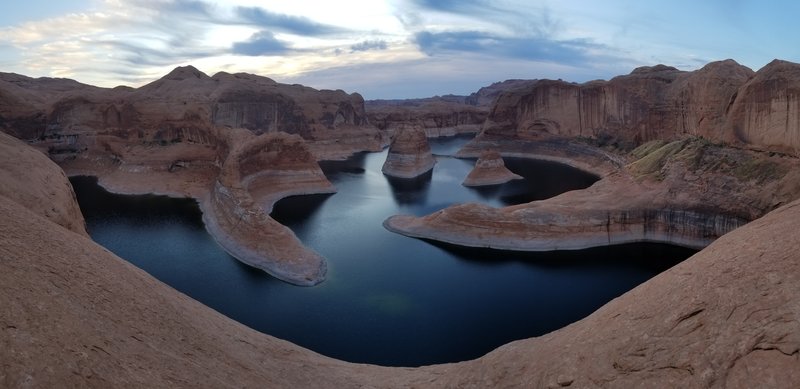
[72,138,692,366]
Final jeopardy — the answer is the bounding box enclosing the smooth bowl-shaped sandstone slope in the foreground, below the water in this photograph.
[0,130,800,388]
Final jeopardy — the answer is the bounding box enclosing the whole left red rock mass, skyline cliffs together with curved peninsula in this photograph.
[0,66,394,285]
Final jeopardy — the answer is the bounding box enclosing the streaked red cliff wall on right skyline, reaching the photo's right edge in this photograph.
[483,60,800,153]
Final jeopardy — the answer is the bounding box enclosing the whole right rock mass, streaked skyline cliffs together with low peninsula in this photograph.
[384,60,800,251]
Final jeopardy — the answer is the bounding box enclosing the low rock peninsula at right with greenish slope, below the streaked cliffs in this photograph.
[384,139,800,251]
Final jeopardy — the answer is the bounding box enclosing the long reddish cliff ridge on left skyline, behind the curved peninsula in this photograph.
[0,66,385,158]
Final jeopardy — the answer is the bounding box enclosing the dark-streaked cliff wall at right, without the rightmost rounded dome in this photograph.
[484,60,754,148]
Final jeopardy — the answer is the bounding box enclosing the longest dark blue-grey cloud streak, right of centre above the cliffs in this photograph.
[414,31,602,64]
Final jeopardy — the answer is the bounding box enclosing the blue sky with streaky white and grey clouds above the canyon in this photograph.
[0,0,800,99]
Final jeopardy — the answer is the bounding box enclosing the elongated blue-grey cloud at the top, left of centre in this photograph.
[234,7,343,36]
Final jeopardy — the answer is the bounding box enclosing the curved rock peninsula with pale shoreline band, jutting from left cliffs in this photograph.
[202,132,336,285]
